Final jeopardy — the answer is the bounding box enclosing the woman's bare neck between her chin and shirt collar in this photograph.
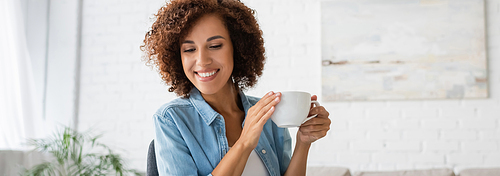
[201,80,243,114]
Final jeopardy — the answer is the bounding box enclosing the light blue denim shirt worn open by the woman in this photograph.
[154,88,292,176]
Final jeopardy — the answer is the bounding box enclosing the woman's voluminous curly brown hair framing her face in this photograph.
[141,0,265,97]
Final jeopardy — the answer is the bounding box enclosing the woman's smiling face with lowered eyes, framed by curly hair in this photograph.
[181,14,234,94]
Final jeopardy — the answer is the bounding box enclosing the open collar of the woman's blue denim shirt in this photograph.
[189,87,252,125]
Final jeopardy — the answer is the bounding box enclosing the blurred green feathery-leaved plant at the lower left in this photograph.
[21,127,141,176]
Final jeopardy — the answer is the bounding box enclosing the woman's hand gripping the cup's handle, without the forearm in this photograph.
[297,95,331,144]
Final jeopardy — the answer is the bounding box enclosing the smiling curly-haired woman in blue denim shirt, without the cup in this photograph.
[142,0,330,176]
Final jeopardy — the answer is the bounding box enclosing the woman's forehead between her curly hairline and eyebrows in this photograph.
[185,14,229,40]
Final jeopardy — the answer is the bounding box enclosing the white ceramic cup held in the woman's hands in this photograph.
[271,91,319,128]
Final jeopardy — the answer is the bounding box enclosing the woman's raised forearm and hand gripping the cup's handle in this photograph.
[285,95,331,176]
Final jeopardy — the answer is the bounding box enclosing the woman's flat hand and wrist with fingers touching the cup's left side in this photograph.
[236,91,281,150]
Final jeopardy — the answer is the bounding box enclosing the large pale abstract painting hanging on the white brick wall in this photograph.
[321,0,488,101]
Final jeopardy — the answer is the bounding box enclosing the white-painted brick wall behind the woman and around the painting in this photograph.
[75,0,500,171]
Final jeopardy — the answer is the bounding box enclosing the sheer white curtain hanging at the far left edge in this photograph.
[0,0,44,150]
